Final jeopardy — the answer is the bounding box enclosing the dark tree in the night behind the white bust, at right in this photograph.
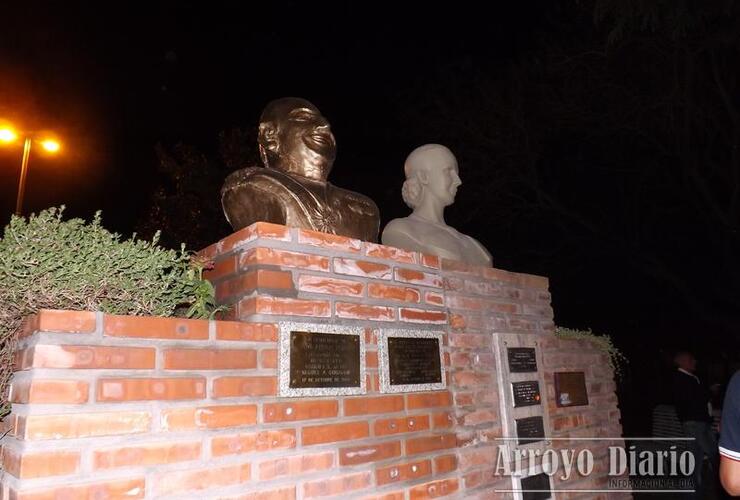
[396,1,740,335]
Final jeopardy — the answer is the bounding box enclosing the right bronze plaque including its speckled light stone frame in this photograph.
[378,330,447,392]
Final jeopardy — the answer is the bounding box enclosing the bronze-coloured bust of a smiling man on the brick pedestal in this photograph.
[221,97,380,242]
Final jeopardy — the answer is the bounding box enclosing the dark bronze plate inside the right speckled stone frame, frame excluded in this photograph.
[388,337,442,385]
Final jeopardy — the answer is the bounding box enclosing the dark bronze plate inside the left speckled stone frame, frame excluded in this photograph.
[289,331,360,389]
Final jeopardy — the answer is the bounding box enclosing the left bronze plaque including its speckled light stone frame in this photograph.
[278,322,365,397]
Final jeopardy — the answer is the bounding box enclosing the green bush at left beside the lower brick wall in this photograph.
[0,207,223,410]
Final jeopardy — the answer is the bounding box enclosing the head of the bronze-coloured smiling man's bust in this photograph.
[257,97,337,181]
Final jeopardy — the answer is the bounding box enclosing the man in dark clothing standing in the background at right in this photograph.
[673,351,719,498]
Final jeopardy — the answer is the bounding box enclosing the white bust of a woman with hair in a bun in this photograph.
[382,144,491,266]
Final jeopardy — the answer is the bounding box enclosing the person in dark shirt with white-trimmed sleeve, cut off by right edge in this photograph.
[719,372,740,496]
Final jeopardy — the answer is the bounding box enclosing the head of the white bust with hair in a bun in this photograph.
[401,144,461,209]
